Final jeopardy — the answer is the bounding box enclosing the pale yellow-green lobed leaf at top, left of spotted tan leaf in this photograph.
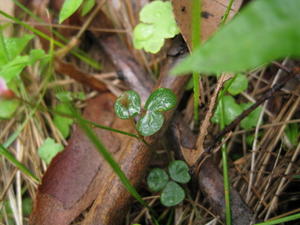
[133,1,179,53]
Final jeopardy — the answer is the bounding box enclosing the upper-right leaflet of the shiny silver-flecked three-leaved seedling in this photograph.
[145,88,177,112]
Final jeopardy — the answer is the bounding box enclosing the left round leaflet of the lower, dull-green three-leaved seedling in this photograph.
[147,168,169,192]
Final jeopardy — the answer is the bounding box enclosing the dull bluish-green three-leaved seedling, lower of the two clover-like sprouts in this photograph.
[147,160,191,207]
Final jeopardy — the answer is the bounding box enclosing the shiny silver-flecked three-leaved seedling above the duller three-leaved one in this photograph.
[114,88,177,136]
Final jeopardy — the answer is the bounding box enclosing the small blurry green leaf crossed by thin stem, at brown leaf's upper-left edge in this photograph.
[53,103,73,138]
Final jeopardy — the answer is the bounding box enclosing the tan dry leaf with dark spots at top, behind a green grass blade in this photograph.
[172,0,243,49]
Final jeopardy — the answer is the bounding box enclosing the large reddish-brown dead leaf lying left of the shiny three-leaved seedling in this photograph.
[30,93,150,225]
